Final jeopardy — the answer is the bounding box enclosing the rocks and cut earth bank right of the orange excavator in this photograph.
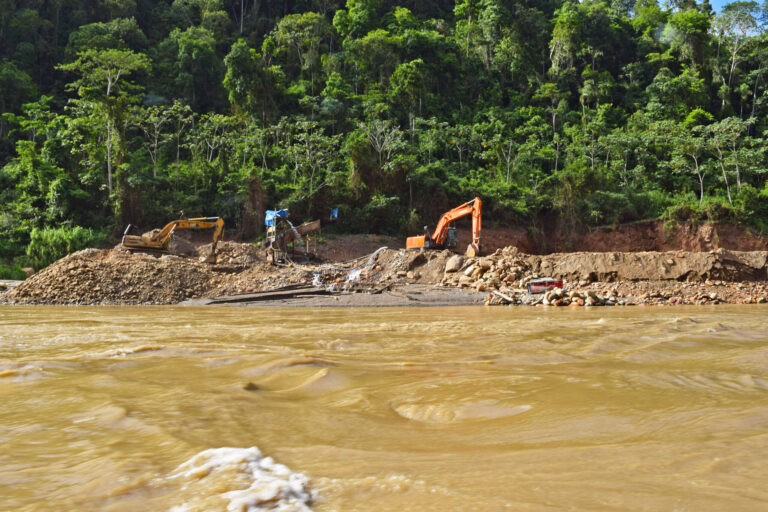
[440,247,768,306]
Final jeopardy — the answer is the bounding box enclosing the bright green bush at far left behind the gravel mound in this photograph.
[27,226,104,269]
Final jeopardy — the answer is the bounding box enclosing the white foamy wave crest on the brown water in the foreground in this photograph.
[169,446,314,512]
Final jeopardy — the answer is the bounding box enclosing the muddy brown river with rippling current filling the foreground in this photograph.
[0,306,768,512]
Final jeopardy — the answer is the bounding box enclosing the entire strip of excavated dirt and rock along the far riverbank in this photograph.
[0,238,768,306]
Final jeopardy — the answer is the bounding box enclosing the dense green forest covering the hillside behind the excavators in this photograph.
[0,0,768,272]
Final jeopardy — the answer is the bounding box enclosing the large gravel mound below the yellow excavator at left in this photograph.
[2,249,221,304]
